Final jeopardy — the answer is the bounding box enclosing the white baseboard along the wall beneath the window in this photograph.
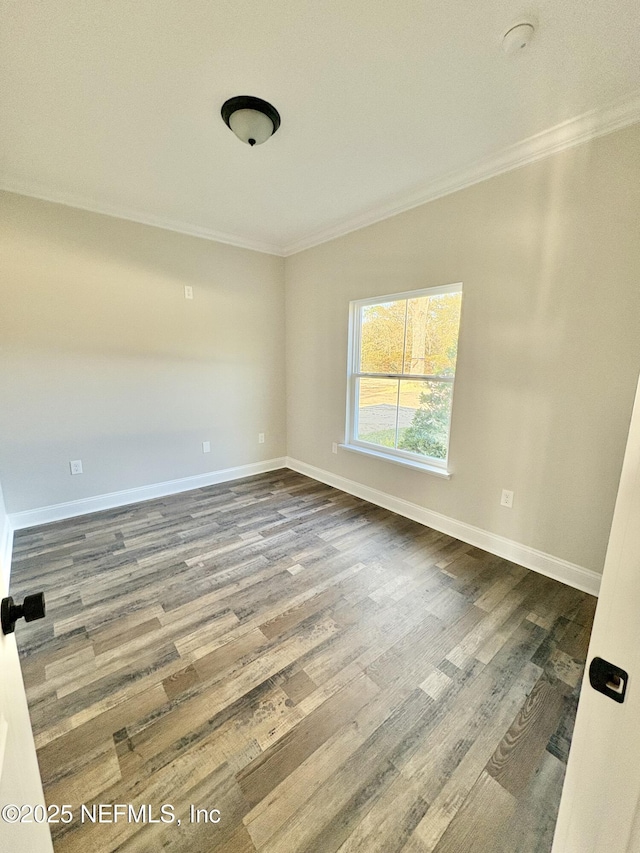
[286,457,601,595]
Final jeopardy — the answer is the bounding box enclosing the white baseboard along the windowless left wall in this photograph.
[9,458,286,530]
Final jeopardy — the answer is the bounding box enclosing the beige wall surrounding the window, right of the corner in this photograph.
[286,125,640,571]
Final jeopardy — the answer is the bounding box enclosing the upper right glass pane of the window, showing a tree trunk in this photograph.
[403,293,462,376]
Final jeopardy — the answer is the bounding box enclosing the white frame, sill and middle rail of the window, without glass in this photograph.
[341,282,462,479]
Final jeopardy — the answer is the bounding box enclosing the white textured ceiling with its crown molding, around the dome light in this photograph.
[0,0,640,255]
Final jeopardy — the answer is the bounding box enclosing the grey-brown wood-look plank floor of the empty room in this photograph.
[12,470,595,853]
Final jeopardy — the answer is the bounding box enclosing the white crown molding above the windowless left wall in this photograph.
[0,175,282,251]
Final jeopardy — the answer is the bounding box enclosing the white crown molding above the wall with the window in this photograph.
[282,91,640,257]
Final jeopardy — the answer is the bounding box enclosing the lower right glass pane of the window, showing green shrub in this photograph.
[398,380,453,459]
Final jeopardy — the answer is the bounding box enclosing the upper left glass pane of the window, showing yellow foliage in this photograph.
[360,299,407,373]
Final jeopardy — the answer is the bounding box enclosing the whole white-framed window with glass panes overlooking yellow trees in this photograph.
[345,284,462,475]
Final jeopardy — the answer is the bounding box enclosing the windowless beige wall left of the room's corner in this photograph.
[0,193,285,512]
